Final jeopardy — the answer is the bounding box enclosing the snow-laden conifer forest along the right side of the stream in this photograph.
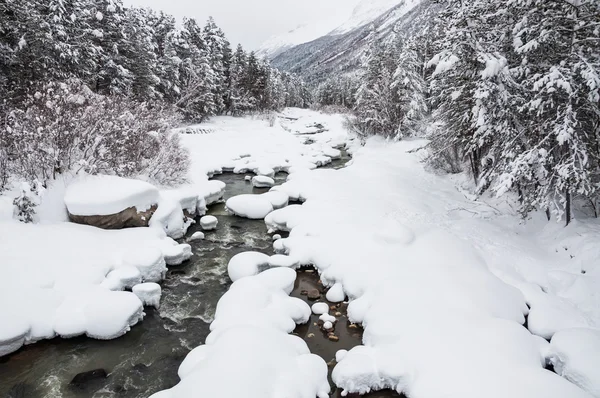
[315,0,600,224]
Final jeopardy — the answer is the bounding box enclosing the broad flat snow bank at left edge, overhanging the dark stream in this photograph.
[0,221,191,354]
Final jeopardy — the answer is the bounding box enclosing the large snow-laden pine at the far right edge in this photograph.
[497,0,600,224]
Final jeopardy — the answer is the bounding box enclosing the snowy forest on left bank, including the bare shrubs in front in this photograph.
[0,0,310,191]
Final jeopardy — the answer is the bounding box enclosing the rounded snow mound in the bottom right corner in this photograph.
[548,328,600,397]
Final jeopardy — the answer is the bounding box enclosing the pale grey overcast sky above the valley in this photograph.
[119,0,359,50]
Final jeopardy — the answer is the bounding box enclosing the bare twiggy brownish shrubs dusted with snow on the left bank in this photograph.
[0,80,189,194]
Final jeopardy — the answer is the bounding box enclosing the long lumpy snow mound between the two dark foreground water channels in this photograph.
[151,268,329,398]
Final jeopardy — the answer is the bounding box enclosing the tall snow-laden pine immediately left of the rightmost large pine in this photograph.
[429,0,519,183]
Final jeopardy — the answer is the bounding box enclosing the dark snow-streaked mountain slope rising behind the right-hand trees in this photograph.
[272,0,439,83]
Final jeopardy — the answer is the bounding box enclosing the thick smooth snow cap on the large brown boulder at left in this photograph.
[65,175,159,216]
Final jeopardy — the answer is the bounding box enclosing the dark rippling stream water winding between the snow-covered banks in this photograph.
[0,151,398,398]
